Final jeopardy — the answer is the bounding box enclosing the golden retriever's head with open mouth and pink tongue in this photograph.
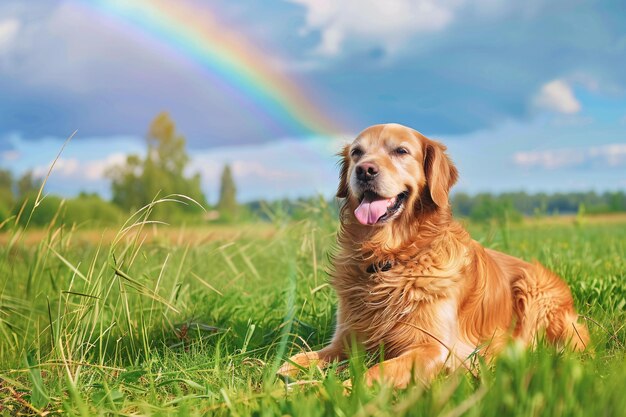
[337,124,458,225]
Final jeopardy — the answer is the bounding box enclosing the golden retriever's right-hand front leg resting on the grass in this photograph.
[364,343,448,388]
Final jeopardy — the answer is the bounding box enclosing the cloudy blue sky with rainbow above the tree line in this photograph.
[0,0,626,202]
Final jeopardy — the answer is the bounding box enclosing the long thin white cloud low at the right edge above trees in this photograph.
[513,143,626,170]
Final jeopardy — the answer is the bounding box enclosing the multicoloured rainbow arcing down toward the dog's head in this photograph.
[82,0,340,139]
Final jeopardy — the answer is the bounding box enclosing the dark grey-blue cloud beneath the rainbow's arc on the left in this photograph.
[0,3,336,147]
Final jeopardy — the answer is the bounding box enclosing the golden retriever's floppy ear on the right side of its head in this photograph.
[424,139,459,207]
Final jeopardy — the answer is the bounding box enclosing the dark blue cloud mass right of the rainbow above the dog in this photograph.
[316,2,626,134]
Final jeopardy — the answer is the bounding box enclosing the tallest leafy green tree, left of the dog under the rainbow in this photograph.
[108,113,206,220]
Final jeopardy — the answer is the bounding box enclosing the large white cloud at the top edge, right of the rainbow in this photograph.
[291,0,464,56]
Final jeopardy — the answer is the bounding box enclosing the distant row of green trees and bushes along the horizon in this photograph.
[0,113,626,226]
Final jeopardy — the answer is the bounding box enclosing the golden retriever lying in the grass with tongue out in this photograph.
[278,124,589,387]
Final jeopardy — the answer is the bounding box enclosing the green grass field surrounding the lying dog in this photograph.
[0,200,626,417]
